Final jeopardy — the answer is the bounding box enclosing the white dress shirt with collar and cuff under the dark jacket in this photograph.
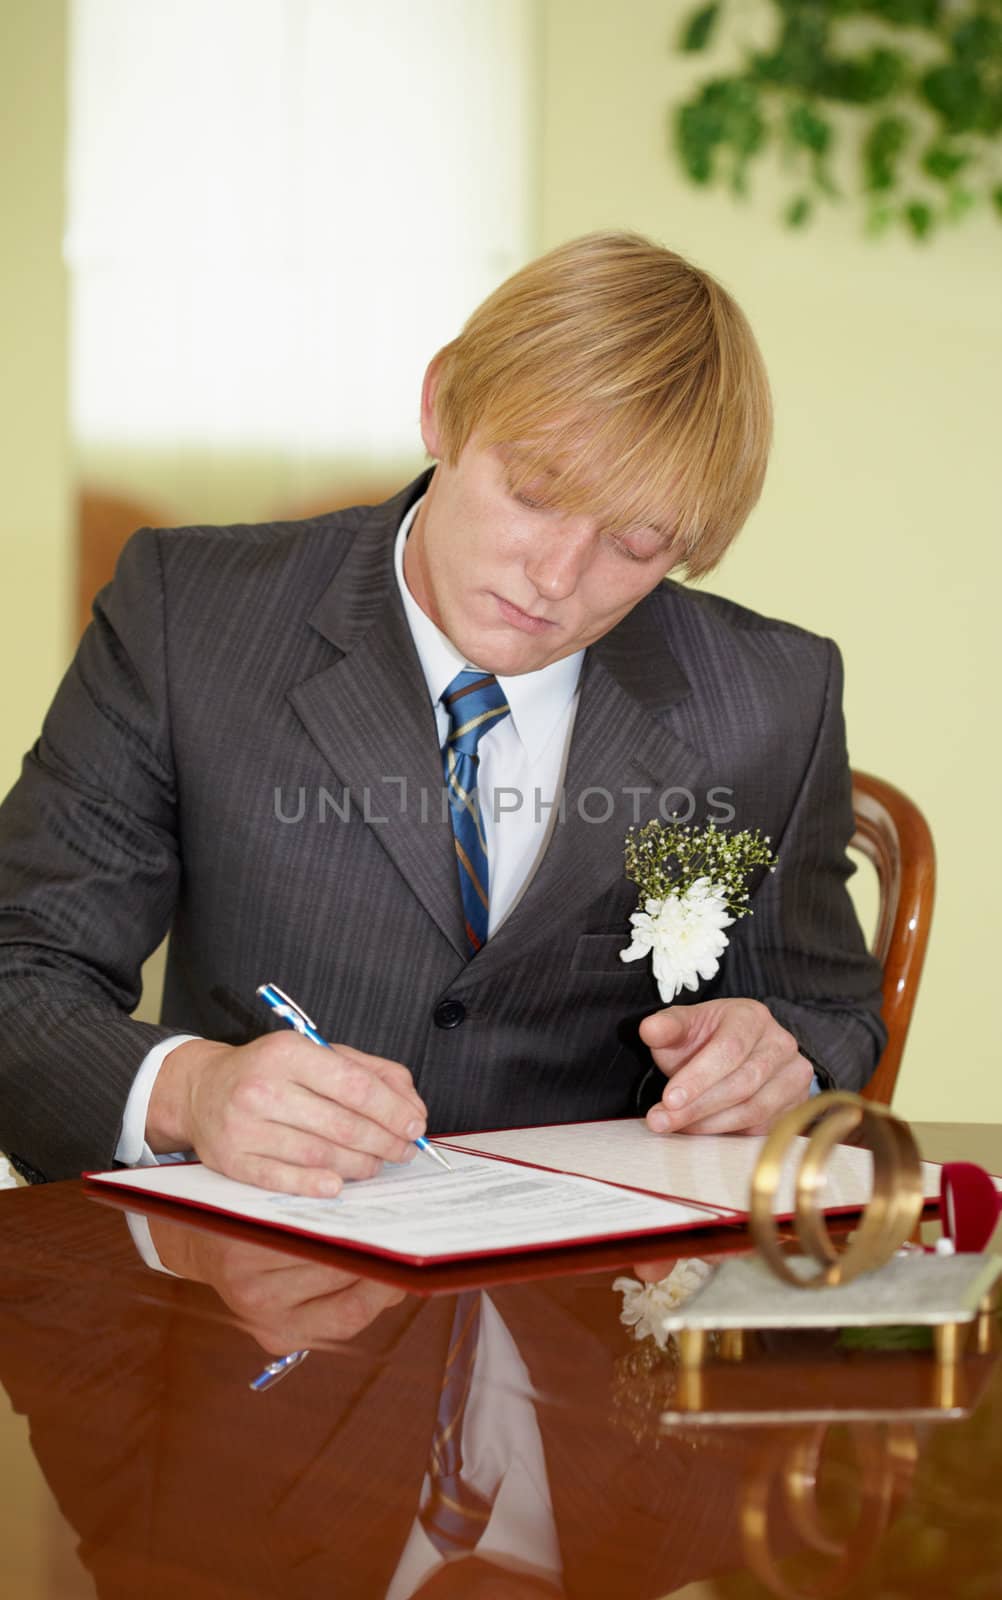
[115,501,584,1166]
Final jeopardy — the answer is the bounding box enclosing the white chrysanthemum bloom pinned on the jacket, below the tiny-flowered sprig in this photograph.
[619,878,735,1005]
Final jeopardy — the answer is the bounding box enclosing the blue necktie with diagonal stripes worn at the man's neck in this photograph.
[442,672,509,955]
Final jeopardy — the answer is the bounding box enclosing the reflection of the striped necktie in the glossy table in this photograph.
[418,1290,491,1555]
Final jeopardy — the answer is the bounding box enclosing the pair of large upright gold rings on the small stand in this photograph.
[749,1090,922,1290]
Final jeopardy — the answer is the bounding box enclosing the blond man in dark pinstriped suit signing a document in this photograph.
[0,235,884,1194]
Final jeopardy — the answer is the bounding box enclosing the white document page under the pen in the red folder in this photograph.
[90,1154,726,1261]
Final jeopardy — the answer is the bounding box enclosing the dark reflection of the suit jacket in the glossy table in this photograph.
[0,1194,747,1600]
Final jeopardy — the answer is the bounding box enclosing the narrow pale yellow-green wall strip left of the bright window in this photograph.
[0,0,72,792]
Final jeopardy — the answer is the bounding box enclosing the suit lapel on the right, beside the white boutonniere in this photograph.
[475,597,711,974]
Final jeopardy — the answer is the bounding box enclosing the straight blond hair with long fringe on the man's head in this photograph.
[435,234,772,578]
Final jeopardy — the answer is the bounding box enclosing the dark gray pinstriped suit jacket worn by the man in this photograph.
[0,467,882,1178]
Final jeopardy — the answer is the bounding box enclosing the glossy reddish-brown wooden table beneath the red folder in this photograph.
[0,1125,1002,1600]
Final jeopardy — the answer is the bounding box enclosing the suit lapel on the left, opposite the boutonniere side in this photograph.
[288,477,467,957]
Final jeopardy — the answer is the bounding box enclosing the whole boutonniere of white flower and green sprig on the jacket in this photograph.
[619,821,776,1005]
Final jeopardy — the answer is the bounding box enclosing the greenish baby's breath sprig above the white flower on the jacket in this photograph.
[626,821,776,917]
